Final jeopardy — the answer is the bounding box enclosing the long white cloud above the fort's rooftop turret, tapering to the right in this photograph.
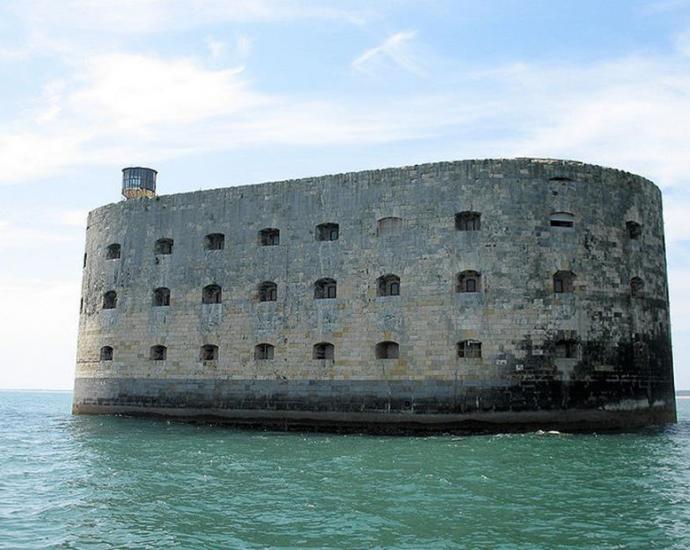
[0,49,494,183]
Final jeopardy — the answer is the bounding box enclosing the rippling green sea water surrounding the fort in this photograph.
[0,392,690,549]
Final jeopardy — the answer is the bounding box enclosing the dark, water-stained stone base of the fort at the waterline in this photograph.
[73,378,676,434]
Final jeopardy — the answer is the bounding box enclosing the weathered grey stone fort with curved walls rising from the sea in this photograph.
[74,159,675,431]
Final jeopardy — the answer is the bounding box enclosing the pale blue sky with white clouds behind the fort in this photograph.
[0,0,690,389]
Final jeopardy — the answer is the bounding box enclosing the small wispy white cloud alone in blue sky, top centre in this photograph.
[352,31,425,76]
